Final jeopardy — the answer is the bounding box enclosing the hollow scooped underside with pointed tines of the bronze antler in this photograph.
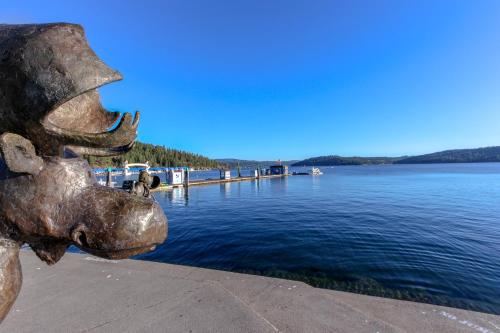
[42,89,139,156]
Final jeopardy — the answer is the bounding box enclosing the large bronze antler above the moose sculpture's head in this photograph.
[0,23,139,155]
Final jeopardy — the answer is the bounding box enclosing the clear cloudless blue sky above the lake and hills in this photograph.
[0,0,500,160]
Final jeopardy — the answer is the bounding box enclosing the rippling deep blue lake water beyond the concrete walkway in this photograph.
[106,163,500,314]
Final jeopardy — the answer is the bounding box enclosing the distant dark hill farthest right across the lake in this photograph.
[394,146,500,164]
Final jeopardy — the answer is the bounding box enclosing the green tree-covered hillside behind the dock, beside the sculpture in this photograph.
[85,142,220,169]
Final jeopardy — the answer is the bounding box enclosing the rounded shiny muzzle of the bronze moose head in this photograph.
[72,186,168,254]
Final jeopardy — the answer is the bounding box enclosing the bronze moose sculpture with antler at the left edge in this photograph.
[0,23,167,322]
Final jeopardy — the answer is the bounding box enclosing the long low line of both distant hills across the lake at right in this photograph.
[293,146,500,166]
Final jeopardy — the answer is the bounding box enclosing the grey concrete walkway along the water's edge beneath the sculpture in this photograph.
[0,251,500,333]
